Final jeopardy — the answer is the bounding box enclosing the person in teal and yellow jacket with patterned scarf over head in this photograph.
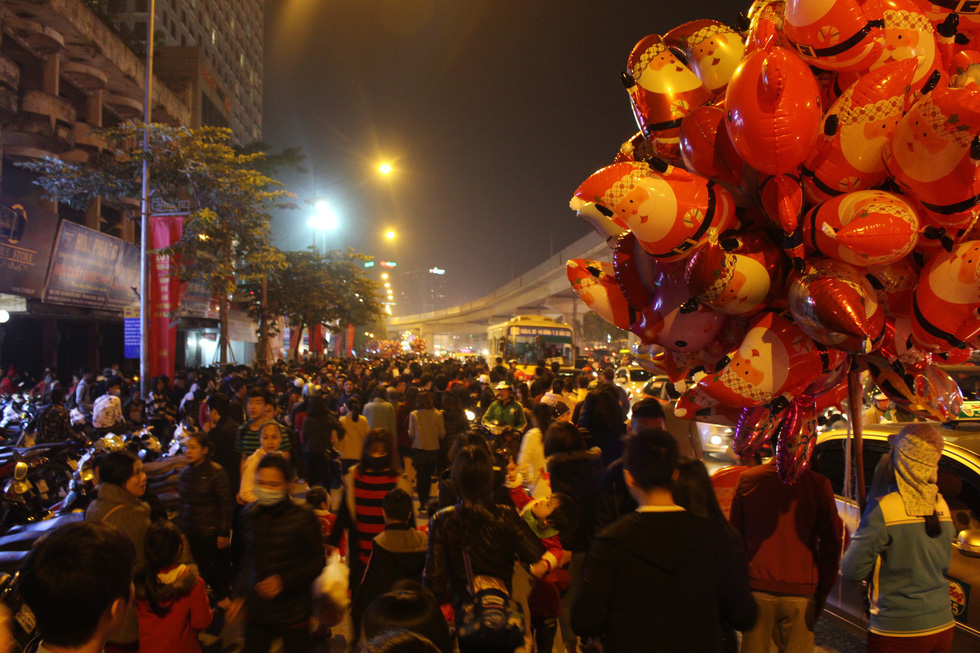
[840,423,956,653]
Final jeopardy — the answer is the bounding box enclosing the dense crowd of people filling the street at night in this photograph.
[3,359,953,653]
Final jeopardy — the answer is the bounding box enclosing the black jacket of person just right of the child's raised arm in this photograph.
[546,447,605,553]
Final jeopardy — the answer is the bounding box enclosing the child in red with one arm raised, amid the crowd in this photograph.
[507,461,578,651]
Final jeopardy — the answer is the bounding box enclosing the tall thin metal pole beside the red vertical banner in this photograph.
[140,0,156,399]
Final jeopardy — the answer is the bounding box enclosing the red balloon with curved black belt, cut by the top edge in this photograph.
[783,0,884,72]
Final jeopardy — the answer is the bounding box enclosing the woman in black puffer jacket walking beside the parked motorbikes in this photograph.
[177,432,235,603]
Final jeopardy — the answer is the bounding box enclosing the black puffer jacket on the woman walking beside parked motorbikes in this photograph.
[177,460,234,537]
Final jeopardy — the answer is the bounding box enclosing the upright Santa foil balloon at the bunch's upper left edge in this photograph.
[623,34,713,160]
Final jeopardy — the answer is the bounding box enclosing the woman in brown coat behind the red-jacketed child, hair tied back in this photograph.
[85,451,150,647]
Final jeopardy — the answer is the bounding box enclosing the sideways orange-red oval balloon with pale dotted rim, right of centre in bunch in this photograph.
[803,190,919,267]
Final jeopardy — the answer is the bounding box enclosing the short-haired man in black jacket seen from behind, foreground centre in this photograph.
[572,430,756,653]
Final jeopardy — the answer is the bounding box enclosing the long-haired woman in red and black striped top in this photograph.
[327,429,412,595]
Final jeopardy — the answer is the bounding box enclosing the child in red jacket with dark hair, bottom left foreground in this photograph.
[136,521,212,653]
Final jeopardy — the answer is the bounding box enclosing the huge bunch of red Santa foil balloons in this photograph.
[568,0,980,482]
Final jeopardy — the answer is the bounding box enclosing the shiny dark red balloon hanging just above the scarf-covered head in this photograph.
[865,354,963,422]
